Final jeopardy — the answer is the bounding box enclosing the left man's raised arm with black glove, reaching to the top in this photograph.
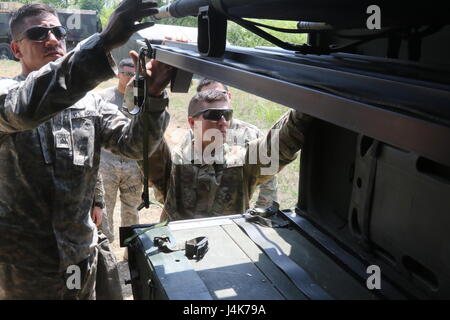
[0,0,156,134]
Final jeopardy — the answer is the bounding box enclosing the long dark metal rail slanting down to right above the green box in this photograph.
[155,46,450,166]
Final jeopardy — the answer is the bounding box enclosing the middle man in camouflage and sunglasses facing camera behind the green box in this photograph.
[142,90,310,220]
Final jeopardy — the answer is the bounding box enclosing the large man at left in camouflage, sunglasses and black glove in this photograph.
[0,0,172,299]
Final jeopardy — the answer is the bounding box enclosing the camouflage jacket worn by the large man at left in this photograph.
[0,34,168,270]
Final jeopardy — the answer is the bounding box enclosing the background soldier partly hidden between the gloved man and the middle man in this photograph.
[98,59,142,242]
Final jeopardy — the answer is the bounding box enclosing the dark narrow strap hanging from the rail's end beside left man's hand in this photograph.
[130,39,154,211]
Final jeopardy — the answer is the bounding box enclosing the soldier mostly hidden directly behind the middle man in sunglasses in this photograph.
[196,78,278,208]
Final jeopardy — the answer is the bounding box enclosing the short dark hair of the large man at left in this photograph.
[9,3,58,40]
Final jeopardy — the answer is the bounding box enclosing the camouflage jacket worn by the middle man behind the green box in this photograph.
[145,110,309,220]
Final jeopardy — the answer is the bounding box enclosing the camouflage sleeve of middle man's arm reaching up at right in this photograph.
[244,110,311,185]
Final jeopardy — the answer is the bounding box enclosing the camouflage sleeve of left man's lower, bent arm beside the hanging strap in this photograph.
[100,87,170,160]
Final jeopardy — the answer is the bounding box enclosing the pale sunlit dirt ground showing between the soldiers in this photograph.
[107,110,188,300]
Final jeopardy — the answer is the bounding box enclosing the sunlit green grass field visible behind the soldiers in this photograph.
[0,60,299,208]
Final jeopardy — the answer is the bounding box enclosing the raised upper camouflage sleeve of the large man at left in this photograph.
[0,34,115,134]
